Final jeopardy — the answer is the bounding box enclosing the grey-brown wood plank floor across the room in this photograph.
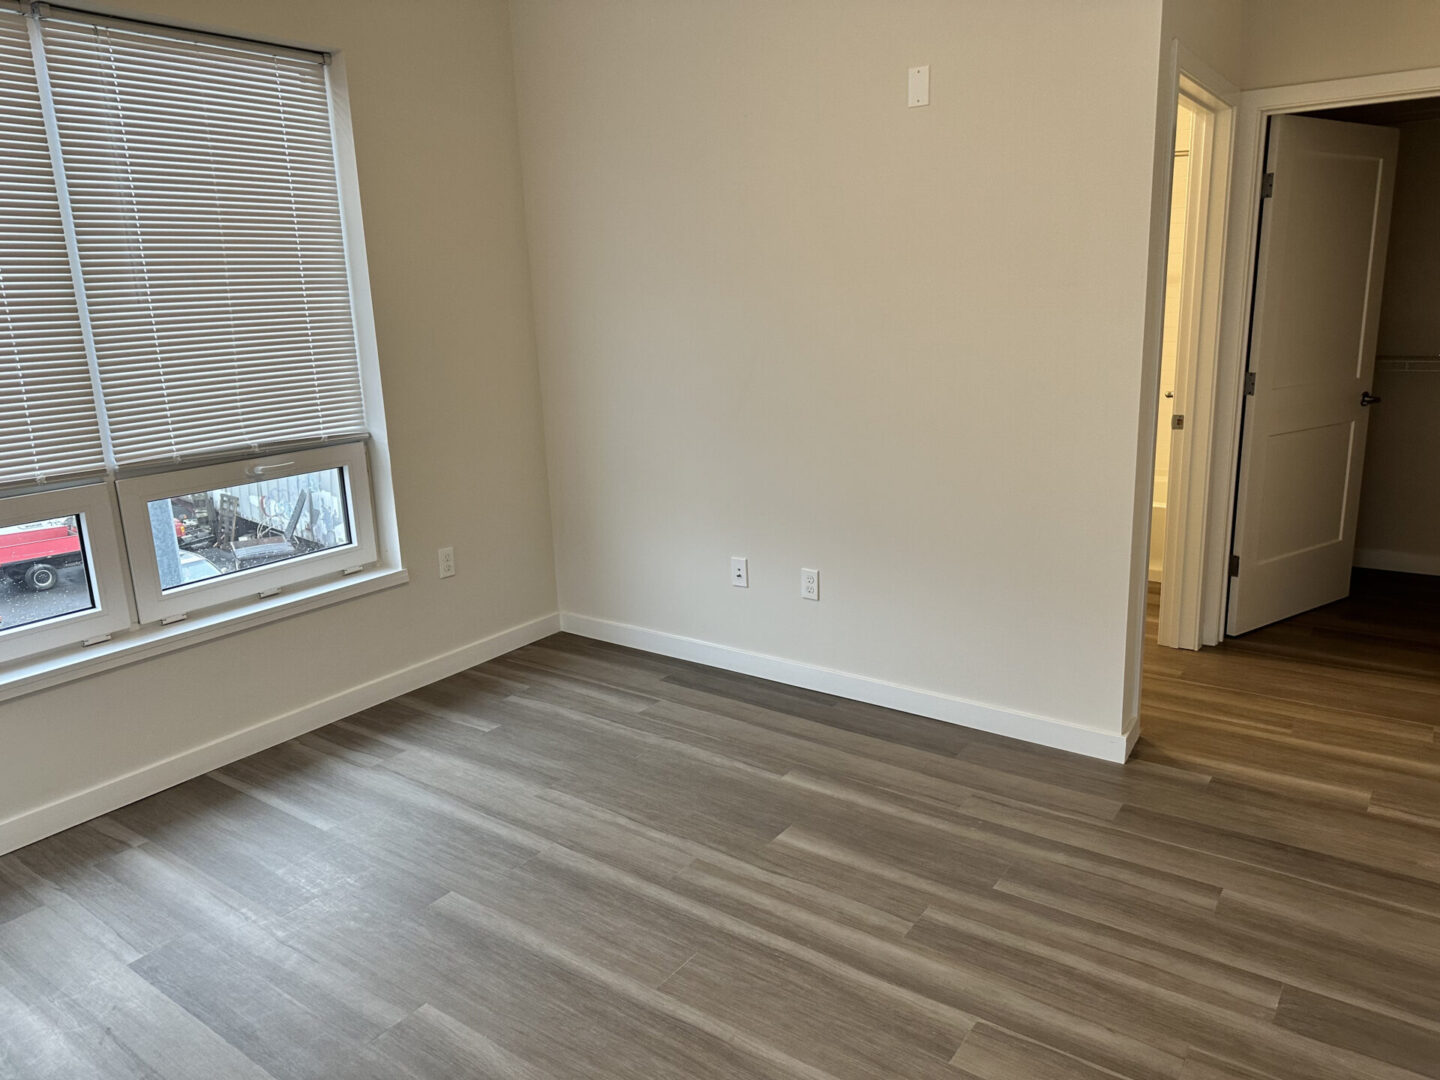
[0,577,1440,1080]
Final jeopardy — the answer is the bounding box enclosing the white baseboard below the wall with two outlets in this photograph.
[560,612,1139,762]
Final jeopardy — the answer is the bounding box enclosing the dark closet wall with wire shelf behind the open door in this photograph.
[1355,120,1440,573]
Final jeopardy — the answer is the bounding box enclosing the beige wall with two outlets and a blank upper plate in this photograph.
[513,0,1161,732]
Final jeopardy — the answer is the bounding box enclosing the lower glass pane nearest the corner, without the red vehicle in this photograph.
[150,468,351,590]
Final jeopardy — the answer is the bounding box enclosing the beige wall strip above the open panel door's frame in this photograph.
[1240,0,1440,89]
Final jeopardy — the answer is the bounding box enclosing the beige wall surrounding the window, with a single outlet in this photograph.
[0,0,556,822]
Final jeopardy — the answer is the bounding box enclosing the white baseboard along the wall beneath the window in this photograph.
[0,615,560,855]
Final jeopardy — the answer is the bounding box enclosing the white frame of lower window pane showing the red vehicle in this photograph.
[0,481,135,665]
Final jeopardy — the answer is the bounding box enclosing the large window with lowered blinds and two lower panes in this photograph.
[0,0,388,678]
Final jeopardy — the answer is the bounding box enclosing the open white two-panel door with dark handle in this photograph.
[1227,117,1400,634]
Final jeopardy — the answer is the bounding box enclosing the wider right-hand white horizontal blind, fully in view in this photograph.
[42,9,364,467]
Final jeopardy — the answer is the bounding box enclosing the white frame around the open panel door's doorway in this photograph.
[1187,68,1440,645]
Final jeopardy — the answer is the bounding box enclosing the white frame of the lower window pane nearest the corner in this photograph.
[115,441,377,625]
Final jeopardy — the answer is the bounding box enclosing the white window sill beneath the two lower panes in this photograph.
[0,566,410,701]
